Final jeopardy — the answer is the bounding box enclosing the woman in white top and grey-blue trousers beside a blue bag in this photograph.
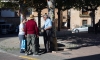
[18,19,26,53]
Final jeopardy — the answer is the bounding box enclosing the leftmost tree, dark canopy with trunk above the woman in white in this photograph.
[1,0,27,21]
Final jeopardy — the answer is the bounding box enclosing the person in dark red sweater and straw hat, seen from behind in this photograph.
[25,15,39,56]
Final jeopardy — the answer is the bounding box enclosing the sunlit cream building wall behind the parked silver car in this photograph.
[70,7,100,29]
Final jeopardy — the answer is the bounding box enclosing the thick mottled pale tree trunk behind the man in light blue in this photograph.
[47,0,57,51]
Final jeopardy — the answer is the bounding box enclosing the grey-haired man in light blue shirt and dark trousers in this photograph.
[43,15,52,52]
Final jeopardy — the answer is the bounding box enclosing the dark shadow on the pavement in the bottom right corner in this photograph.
[64,54,100,60]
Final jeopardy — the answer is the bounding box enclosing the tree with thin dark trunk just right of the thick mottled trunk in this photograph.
[56,0,74,31]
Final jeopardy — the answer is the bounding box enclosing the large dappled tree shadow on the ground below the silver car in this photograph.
[57,30,100,49]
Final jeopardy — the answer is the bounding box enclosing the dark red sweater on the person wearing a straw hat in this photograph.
[25,19,39,35]
